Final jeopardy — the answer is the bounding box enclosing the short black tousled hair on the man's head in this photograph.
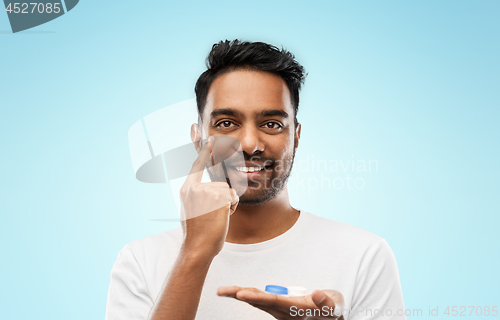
[194,39,307,127]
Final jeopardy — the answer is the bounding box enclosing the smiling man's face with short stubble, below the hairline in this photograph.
[202,70,300,205]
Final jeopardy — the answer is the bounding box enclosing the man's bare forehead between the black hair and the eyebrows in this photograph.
[203,70,294,119]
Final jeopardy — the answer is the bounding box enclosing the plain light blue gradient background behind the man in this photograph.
[0,0,500,319]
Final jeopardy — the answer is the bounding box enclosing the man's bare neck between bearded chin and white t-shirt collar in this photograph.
[226,186,299,244]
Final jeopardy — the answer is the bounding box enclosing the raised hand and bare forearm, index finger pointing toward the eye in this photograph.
[149,136,239,320]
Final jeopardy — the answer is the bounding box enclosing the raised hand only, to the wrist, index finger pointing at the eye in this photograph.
[180,137,239,259]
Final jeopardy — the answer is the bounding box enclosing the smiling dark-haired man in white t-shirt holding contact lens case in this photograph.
[106,40,405,320]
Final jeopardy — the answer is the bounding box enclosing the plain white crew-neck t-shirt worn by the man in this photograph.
[105,211,406,320]
